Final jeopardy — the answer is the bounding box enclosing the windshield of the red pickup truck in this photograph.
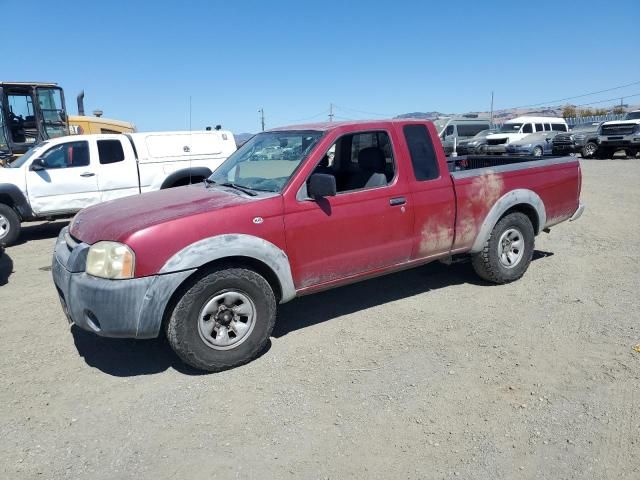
[209,130,322,192]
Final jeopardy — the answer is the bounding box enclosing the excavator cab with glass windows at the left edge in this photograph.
[0,82,69,156]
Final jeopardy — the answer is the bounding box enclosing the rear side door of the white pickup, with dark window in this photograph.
[96,135,140,202]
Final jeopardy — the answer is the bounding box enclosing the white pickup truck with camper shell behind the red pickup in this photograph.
[0,130,236,246]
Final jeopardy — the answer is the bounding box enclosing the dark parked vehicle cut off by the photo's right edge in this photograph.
[597,110,640,158]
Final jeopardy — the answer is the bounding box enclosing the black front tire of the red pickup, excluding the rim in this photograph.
[166,268,276,372]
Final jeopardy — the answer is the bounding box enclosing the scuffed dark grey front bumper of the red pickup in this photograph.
[52,228,195,338]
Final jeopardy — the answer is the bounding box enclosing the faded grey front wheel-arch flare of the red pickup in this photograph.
[159,234,296,303]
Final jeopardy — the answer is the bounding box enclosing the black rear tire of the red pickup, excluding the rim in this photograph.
[471,212,535,284]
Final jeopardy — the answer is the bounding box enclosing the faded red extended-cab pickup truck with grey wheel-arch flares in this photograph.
[53,120,583,371]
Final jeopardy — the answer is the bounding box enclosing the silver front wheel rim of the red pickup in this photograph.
[198,290,256,350]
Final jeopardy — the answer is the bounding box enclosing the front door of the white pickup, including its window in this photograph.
[26,140,100,215]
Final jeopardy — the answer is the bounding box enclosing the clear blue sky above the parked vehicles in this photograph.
[0,0,640,133]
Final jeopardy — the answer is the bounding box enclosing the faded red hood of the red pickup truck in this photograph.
[69,184,260,245]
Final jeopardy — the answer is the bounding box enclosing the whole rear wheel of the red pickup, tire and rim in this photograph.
[471,212,535,284]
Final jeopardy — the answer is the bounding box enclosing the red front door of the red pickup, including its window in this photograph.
[285,127,413,289]
